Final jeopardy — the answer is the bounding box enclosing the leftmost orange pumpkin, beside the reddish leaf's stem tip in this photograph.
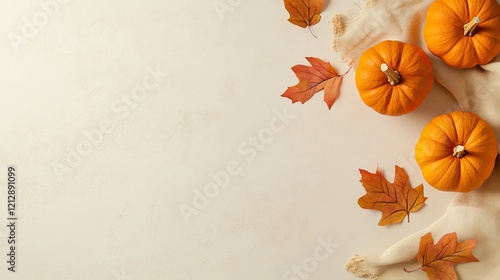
[356,41,434,116]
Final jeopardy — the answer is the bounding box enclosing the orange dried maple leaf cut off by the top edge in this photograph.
[285,0,324,37]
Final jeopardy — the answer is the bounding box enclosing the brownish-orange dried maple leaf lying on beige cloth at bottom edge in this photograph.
[404,232,479,280]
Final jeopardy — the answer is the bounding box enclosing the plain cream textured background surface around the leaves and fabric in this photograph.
[0,0,453,280]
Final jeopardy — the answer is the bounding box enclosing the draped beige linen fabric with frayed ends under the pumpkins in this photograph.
[332,0,500,280]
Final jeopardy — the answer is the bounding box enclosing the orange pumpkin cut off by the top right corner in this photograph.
[424,0,500,68]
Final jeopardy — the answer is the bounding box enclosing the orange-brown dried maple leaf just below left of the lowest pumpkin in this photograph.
[358,166,427,226]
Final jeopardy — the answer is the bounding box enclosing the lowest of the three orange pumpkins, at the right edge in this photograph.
[415,112,498,192]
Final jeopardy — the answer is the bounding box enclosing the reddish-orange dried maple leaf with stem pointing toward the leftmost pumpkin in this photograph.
[281,57,349,109]
